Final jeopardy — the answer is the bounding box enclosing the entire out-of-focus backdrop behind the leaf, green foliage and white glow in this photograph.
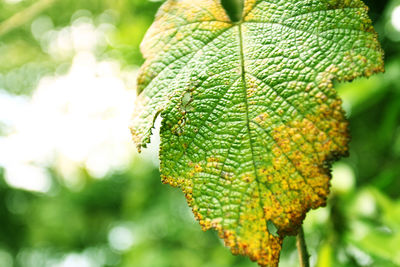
[0,0,400,267]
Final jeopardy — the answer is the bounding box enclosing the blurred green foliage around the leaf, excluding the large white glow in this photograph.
[0,0,400,267]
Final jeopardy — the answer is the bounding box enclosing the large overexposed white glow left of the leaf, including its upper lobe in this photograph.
[0,14,158,192]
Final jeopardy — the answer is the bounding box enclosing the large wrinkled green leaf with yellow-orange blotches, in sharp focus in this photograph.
[131,0,383,266]
